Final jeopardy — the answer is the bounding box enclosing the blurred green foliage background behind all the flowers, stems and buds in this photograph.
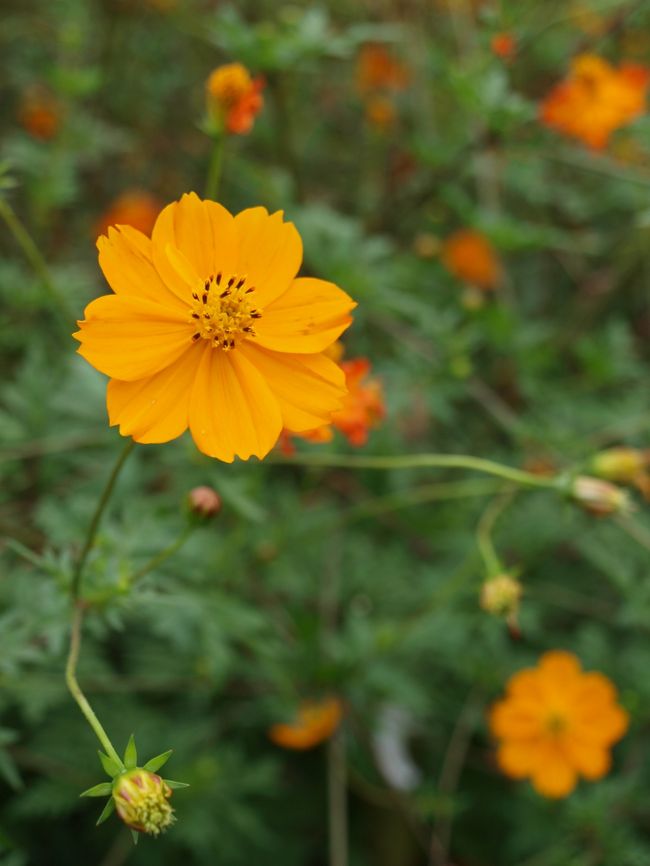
[0,0,650,866]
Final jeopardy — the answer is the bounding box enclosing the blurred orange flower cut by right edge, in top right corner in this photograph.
[540,54,650,150]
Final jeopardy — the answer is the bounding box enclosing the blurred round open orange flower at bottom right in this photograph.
[489,650,628,798]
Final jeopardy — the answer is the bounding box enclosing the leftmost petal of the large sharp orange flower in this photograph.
[73,295,192,382]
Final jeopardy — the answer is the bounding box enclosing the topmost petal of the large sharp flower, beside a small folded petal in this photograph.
[151,193,238,300]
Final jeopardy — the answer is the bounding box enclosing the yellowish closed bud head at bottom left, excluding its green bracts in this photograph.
[113,767,175,836]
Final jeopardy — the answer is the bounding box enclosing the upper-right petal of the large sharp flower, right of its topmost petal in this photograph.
[235,207,302,309]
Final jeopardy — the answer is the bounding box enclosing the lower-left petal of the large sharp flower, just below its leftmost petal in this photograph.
[106,343,202,443]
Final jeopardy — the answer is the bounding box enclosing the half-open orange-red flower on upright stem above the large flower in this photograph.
[206,63,264,135]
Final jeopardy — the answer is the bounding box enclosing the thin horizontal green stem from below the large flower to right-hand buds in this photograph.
[275,454,559,489]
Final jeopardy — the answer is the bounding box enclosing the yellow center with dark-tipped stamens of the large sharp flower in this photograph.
[189,273,262,352]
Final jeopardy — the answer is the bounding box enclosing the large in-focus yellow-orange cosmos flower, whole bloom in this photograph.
[74,193,355,462]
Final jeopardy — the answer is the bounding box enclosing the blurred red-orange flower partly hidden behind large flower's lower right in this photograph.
[280,358,386,454]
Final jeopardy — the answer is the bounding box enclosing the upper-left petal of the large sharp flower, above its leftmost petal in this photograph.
[97,226,186,310]
